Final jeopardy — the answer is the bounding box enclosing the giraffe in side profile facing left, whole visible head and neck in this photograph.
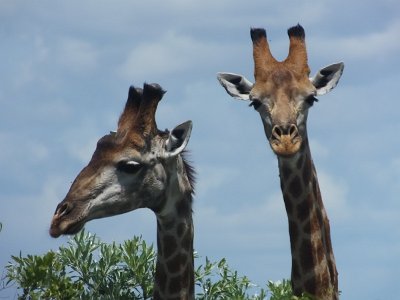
[50,84,194,299]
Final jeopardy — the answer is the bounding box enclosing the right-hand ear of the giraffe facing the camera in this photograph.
[310,62,344,96]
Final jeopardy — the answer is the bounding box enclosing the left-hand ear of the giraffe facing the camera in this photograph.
[217,72,253,100]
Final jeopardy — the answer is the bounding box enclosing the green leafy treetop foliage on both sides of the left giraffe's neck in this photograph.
[3,231,307,300]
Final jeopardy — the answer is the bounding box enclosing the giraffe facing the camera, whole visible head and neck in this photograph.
[218,25,344,299]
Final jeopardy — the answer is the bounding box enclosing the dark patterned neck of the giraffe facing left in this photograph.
[153,158,194,300]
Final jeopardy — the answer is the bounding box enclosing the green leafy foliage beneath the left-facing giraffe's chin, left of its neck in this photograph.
[6,231,155,299]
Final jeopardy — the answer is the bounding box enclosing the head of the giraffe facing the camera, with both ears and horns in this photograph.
[218,25,344,157]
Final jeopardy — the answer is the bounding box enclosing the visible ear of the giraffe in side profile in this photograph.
[165,121,192,158]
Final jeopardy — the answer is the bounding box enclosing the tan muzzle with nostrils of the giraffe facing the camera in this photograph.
[269,124,302,157]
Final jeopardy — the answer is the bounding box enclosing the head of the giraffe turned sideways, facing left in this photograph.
[50,84,193,237]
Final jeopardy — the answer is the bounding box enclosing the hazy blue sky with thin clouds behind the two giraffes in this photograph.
[0,0,400,299]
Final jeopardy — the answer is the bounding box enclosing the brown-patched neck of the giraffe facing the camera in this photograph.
[278,139,338,299]
